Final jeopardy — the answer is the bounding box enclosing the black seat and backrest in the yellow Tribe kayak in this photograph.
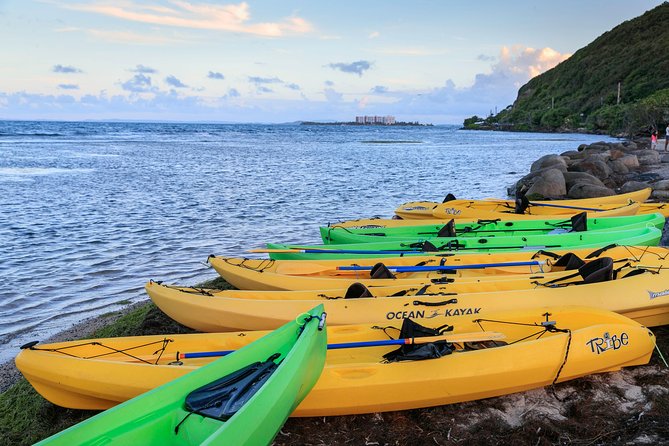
[383,319,453,362]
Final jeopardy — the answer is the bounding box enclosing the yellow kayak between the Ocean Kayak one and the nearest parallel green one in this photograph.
[207,245,669,291]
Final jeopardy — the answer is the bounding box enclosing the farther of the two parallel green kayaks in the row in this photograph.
[320,212,665,244]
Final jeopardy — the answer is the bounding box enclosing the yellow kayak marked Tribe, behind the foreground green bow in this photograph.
[16,307,655,416]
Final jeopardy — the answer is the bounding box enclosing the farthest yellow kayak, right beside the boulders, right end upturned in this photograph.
[395,188,652,219]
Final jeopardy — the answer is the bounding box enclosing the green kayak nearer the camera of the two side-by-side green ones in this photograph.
[262,226,662,260]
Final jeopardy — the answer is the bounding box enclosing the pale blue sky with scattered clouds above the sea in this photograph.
[0,0,662,124]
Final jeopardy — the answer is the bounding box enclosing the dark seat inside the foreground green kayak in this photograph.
[186,355,279,421]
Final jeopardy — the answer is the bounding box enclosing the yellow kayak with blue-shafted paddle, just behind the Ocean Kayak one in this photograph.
[208,245,669,292]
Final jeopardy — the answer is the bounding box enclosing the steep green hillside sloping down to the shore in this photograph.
[465,2,669,134]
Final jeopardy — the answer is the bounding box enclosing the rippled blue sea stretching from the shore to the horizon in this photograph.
[0,121,616,361]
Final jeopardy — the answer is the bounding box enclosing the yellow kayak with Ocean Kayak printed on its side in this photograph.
[146,258,669,332]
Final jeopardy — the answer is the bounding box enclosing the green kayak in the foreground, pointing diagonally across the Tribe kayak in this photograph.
[38,305,327,446]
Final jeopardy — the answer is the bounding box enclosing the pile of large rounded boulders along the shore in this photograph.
[508,139,669,201]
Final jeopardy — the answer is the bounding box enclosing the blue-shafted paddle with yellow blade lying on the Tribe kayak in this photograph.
[177,331,506,359]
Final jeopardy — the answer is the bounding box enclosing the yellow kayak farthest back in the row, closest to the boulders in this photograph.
[395,188,652,219]
